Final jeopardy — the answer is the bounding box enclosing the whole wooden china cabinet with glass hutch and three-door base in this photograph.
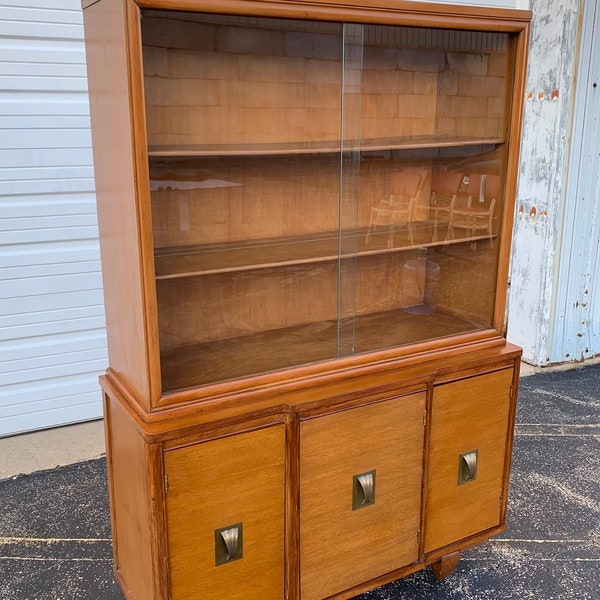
[83,0,530,600]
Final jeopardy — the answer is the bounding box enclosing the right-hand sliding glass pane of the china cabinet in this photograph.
[356,25,512,352]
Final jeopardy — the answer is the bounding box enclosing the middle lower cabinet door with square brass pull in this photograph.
[300,392,426,600]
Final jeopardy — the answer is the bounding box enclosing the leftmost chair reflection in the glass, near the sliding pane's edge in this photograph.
[365,169,425,248]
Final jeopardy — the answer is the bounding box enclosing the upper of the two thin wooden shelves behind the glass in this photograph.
[148,136,505,158]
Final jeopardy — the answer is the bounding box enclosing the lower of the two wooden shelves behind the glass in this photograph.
[155,221,496,280]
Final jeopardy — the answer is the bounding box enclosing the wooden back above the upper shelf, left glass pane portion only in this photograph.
[143,13,342,146]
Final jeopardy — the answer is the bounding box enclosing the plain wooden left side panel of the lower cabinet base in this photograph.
[105,396,155,600]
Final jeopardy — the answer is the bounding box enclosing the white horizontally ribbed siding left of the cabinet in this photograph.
[0,0,107,436]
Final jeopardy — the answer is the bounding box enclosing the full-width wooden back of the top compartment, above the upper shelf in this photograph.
[142,11,512,146]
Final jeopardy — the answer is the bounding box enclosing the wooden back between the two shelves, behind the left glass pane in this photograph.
[150,155,340,248]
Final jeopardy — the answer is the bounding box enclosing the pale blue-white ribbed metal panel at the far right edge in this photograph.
[550,0,600,362]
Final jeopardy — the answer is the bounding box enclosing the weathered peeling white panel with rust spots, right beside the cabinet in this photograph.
[507,0,581,365]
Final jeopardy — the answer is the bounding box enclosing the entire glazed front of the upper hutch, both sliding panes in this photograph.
[142,10,513,391]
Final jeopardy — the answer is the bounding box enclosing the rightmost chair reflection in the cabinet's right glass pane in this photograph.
[446,174,500,245]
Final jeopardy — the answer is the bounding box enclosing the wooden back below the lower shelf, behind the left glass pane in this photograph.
[157,261,338,349]
